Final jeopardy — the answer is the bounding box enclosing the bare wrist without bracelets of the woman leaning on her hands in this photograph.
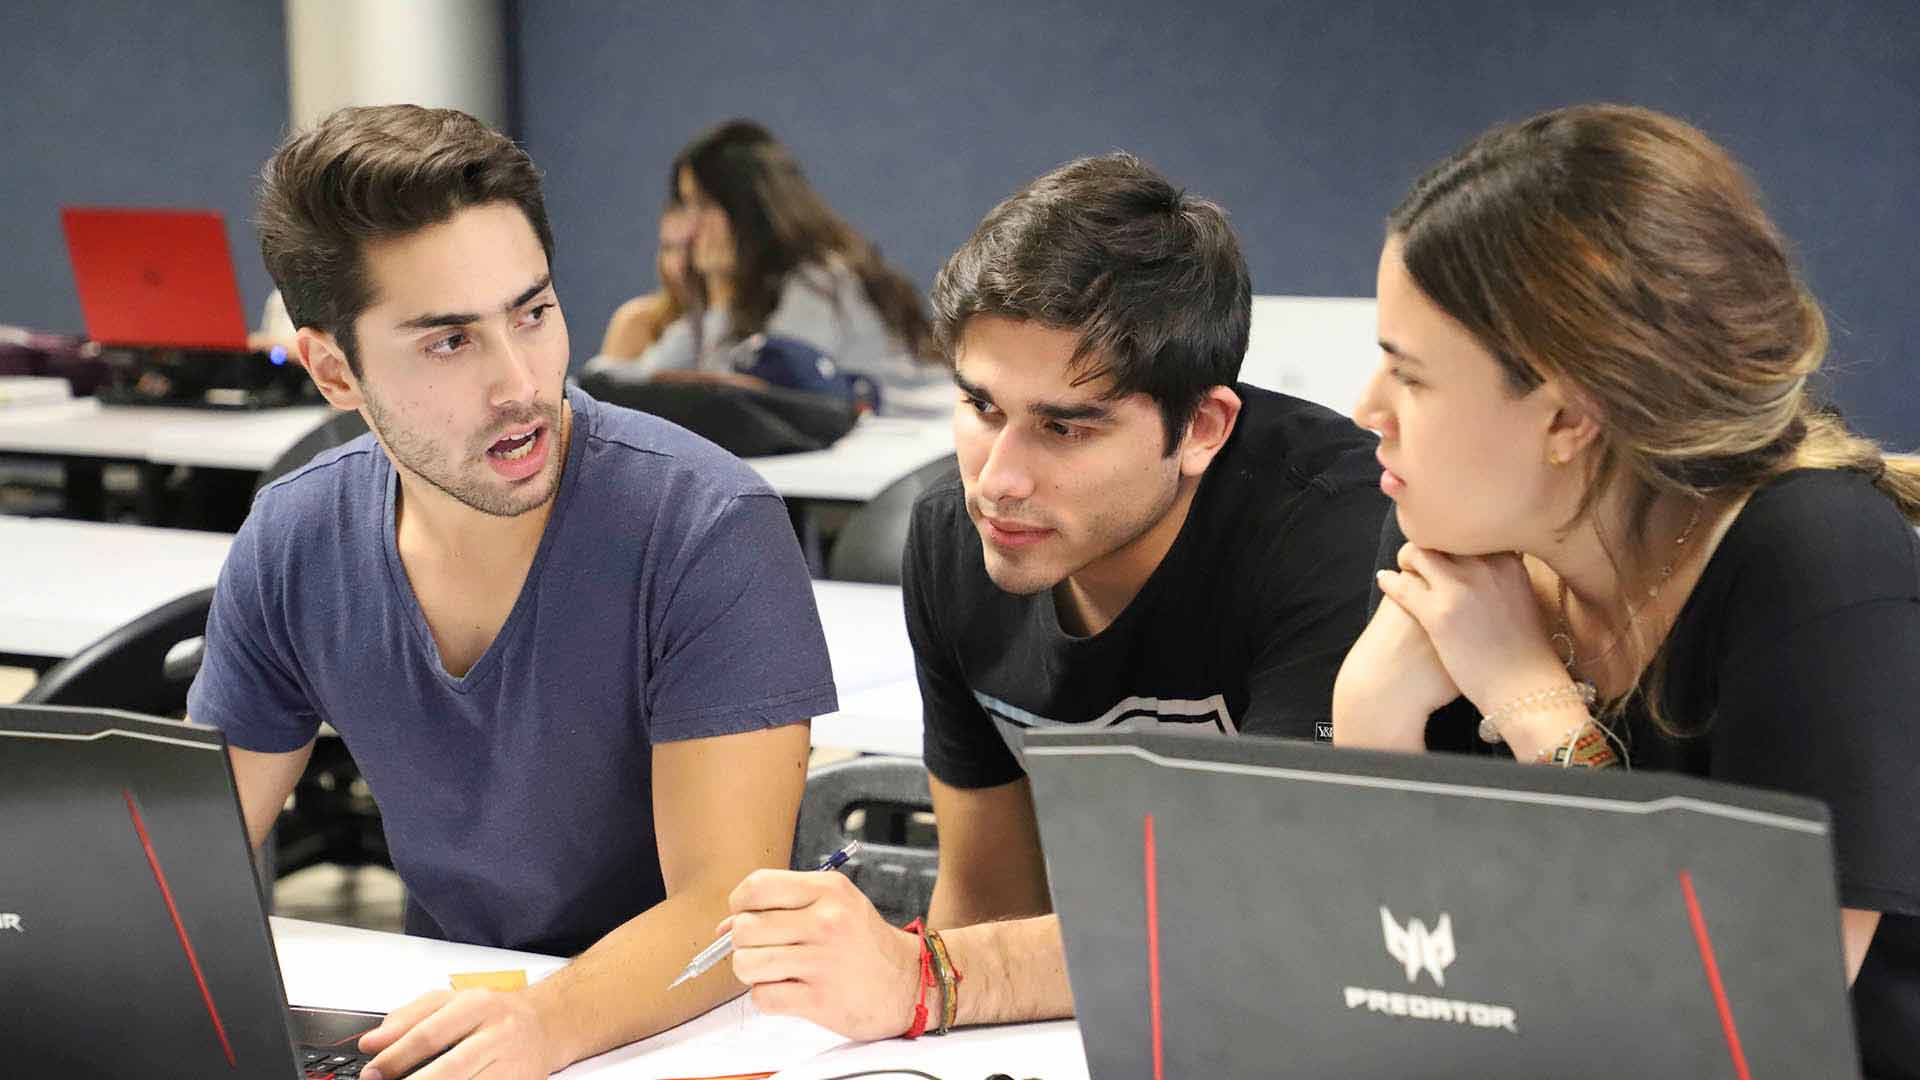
[1332,596,1459,751]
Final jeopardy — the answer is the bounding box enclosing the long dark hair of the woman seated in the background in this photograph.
[668,119,939,361]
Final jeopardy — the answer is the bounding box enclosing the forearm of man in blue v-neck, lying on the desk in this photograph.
[524,882,745,1072]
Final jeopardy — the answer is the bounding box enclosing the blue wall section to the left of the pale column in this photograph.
[0,0,286,332]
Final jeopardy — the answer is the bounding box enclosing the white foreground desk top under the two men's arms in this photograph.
[273,919,1087,1080]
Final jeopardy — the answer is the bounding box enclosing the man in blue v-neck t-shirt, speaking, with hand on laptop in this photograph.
[188,106,835,1078]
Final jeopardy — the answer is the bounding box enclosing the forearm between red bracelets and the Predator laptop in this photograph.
[925,915,1073,1024]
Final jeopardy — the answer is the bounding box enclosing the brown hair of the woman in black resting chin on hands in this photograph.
[1388,106,1920,721]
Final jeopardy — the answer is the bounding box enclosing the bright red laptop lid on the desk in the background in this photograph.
[60,208,246,350]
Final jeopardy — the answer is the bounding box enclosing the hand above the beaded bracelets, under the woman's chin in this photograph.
[1379,544,1569,715]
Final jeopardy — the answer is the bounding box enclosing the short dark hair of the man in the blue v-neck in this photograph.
[255,106,553,375]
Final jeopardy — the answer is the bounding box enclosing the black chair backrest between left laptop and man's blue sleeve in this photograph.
[21,588,213,717]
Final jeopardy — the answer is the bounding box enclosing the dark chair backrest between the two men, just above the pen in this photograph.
[793,757,941,926]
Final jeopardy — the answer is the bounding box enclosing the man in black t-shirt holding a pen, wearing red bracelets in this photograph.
[714,154,1388,1038]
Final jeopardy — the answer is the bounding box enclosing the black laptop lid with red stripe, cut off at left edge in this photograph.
[0,705,300,1078]
